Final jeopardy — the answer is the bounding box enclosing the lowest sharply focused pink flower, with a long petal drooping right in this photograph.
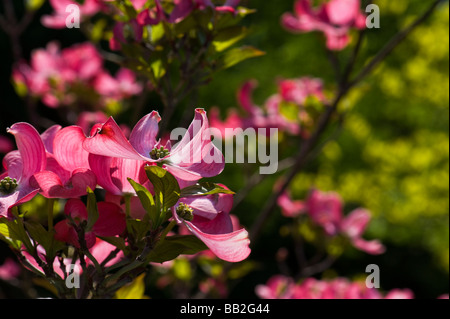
[173,188,250,262]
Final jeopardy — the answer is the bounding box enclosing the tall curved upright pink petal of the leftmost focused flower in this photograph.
[8,123,46,183]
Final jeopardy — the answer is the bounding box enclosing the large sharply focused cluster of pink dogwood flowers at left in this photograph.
[0,109,250,270]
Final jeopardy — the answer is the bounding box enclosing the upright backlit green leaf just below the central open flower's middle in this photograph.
[145,166,181,216]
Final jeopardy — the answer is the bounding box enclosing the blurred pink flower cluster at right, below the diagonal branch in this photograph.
[278,189,385,255]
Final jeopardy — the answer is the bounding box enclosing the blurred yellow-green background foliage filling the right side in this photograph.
[199,0,449,298]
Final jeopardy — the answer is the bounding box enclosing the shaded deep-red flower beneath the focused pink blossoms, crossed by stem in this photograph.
[55,199,126,249]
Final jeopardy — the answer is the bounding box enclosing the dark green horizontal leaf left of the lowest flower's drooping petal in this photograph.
[148,235,208,263]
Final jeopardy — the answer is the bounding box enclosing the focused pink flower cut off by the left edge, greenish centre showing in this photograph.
[0,123,47,217]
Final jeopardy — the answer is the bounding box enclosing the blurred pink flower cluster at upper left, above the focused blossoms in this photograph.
[12,42,143,109]
